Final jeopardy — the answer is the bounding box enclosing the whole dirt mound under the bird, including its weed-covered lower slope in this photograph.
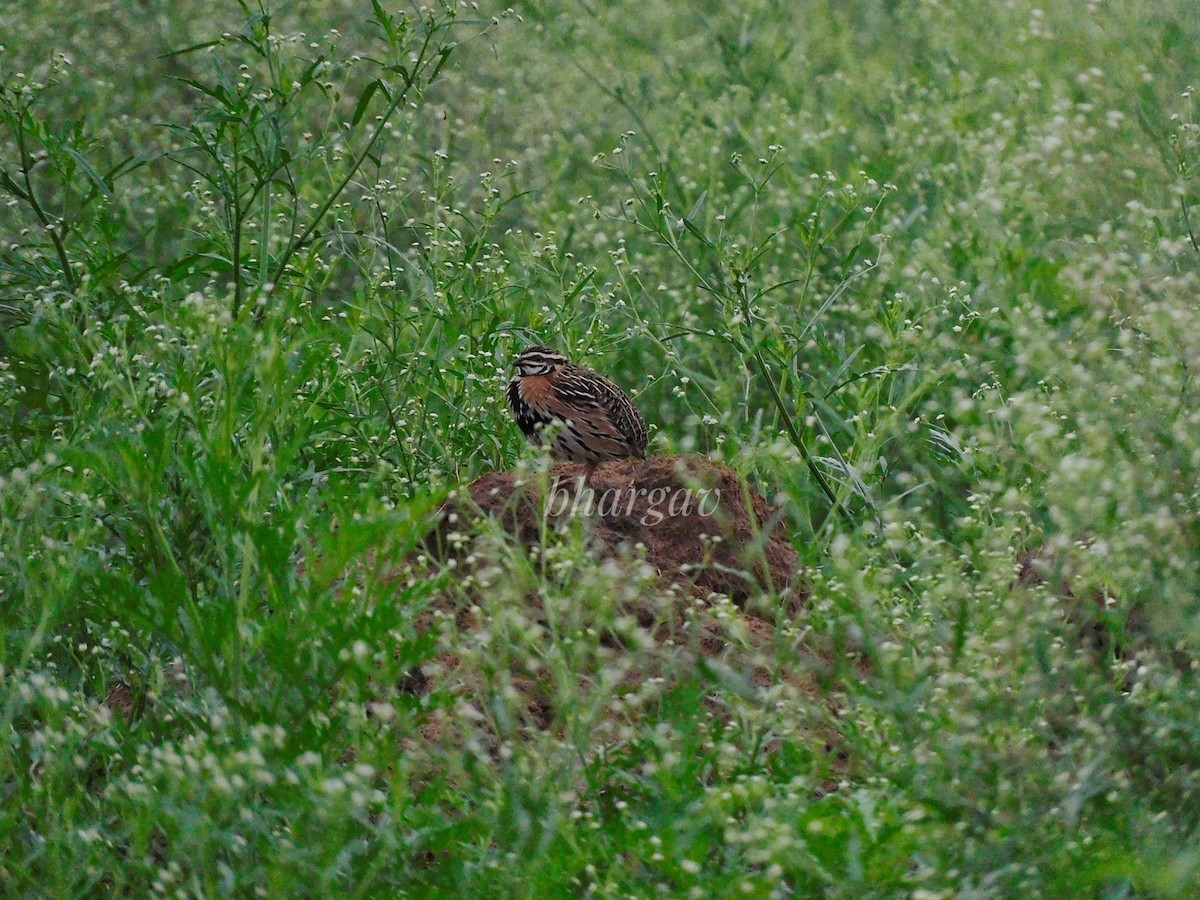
[403,456,823,754]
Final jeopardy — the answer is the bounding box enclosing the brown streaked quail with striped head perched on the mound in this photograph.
[508,346,647,485]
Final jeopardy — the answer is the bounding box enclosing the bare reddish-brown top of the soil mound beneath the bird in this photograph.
[431,456,803,605]
